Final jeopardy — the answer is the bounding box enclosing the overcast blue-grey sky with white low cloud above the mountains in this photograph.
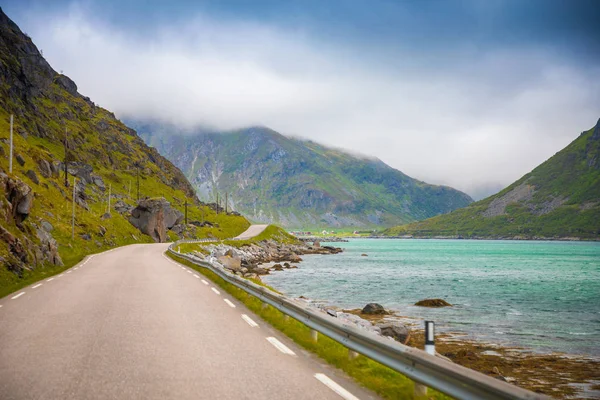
[2,0,600,198]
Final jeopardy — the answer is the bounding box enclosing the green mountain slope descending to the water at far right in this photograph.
[385,120,600,239]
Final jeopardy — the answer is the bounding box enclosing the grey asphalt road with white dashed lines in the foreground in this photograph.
[0,244,374,400]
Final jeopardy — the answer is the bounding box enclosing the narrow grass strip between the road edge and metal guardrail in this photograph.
[167,253,450,399]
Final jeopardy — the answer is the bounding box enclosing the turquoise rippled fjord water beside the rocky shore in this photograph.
[264,239,600,357]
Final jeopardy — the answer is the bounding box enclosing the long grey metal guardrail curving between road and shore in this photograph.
[168,241,550,400]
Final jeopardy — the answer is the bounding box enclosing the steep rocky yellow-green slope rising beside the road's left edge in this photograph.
[0,10,249,297]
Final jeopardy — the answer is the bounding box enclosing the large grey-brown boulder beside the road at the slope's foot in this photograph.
[129,197,183,243]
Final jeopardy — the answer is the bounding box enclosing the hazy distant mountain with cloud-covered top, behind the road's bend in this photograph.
[129,121,472,228]
